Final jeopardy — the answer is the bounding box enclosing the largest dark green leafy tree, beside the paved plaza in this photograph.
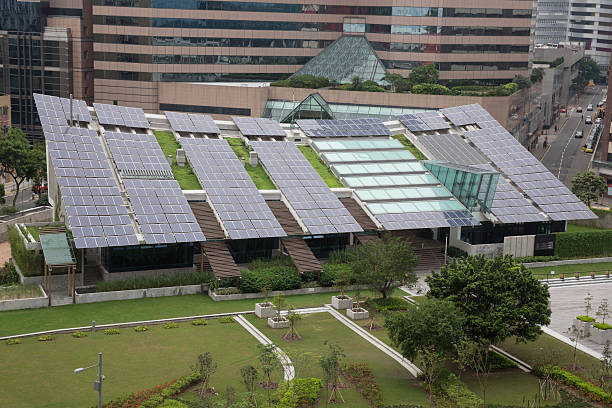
[425,255,551,345]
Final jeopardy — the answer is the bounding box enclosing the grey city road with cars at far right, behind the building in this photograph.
[541,86,605,187]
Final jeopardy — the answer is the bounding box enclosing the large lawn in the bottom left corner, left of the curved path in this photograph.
[0,320,258,408]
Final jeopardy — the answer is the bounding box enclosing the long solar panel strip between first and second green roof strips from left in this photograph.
[180,138,286,239]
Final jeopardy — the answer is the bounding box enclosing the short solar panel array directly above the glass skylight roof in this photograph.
[296,118,391,137]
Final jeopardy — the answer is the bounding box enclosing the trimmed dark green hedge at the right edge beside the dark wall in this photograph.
[555,230,612,258]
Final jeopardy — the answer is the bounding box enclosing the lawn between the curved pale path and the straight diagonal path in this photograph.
[248,313,428,407]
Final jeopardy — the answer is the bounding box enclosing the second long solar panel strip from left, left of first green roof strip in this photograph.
[104,132,205,244]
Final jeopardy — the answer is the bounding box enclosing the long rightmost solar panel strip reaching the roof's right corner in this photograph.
[465,125,596,221]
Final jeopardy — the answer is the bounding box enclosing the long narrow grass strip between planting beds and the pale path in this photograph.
[0,292,372,336]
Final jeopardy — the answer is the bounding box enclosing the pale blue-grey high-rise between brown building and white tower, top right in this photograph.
[535,0,569,44]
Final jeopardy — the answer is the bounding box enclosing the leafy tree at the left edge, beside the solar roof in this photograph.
[0,128,45,207]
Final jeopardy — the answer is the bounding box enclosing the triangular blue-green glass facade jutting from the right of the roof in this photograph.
[423,161,499,212]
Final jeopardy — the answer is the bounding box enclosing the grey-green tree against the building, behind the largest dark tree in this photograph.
[351,234,417,299]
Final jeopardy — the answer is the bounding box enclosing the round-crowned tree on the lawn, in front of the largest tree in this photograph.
[385,298,463,405]
